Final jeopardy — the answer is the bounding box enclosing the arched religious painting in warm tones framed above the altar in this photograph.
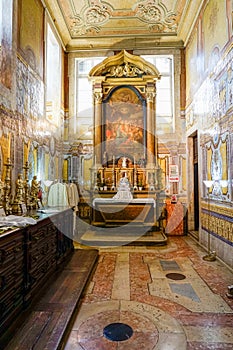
[103,86,145,159]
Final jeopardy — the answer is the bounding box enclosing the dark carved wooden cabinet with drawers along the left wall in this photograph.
[0,209,74,333]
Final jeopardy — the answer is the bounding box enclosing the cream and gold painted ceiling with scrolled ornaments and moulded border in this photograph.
[44,0,204,51]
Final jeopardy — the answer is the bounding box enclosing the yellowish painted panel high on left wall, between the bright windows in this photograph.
[19,0,44,78]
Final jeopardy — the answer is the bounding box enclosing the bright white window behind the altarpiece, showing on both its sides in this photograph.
[75,55,174,140]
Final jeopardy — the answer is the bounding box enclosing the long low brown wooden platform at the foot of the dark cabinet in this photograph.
[0,249,98,350]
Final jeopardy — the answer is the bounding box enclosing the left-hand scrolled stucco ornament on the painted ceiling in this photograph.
[71,0,111,35]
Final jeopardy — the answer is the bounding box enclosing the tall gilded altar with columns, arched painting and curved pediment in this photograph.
[89,50,162,232]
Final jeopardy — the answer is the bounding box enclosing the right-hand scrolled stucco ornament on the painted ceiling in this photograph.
[135,0,177,33]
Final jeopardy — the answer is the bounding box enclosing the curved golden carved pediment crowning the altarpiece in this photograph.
[89,50,160,79]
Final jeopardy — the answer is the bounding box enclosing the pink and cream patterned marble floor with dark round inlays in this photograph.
[65,236,233,350]
